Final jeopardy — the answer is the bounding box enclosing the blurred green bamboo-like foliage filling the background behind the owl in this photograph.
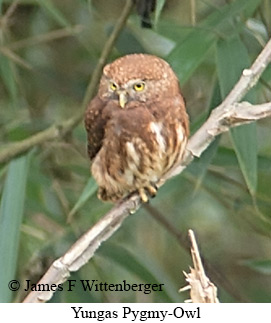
[0,0,271,302]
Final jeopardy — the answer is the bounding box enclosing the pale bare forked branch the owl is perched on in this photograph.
[24,40,271,302]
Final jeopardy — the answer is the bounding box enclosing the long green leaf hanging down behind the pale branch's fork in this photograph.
[217,36,257,195]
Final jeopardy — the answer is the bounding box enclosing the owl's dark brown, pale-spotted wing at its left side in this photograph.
[85,96,106,160]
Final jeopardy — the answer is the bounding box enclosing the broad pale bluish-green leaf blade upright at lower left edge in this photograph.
[0,154,29,302]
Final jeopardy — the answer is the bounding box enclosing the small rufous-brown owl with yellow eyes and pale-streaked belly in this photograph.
[85,54,189,202]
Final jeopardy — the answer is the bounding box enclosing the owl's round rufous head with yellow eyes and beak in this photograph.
[99,54,179,108]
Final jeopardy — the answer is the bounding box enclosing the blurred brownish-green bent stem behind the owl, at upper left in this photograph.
[0,0,133,163]
